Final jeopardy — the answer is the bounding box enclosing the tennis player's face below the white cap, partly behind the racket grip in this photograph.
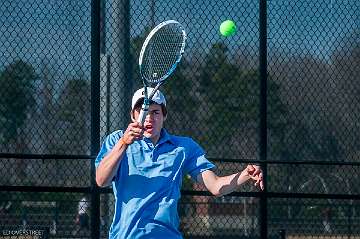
[134,104,165,142]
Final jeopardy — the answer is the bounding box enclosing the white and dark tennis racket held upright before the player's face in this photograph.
[138,20,186,125]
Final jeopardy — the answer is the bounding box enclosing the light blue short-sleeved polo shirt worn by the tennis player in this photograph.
[95,129,215,239]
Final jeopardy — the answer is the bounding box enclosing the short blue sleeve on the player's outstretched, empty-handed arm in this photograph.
[185,140,215,180]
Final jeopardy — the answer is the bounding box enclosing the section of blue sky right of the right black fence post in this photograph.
[268,0,360,59]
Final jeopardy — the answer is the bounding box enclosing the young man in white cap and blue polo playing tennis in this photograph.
[95,88,263,239]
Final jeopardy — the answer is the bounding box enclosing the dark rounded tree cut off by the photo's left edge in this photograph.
[0,60,38,143]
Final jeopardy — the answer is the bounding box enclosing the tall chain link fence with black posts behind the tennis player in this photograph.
[0,0,360,238]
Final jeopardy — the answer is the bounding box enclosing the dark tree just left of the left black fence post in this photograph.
[48,77,91,185]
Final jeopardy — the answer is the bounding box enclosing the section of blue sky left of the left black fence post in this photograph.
[0,0,90,74]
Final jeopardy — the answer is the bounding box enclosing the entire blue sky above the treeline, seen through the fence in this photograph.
[0,0,360,75]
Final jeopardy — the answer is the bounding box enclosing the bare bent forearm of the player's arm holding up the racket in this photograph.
[96,140,127,187]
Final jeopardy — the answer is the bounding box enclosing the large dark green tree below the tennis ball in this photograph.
[200,43,286,158]
